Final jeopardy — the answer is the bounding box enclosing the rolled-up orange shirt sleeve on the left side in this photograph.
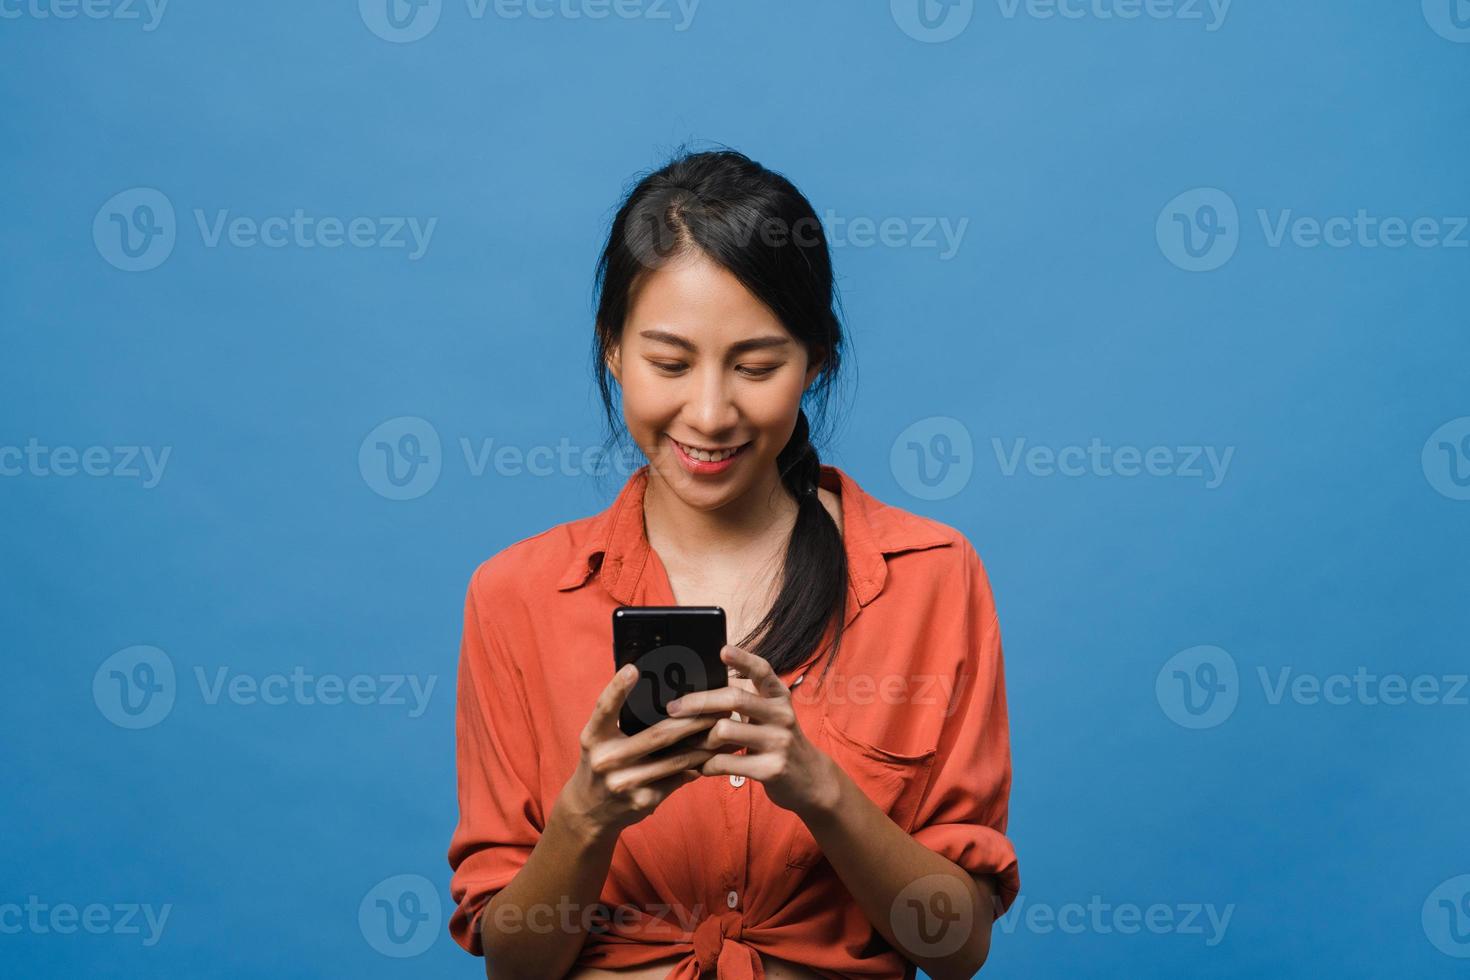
[448,560,545,956]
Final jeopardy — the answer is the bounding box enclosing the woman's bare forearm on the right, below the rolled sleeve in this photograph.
[803,763,995,980]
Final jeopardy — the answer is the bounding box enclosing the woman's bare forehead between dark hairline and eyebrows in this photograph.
[625,253,791,348]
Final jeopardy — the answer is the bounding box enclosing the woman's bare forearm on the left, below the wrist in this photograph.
[479,804,617,980]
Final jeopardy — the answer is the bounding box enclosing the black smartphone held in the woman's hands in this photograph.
[613,605,729,735]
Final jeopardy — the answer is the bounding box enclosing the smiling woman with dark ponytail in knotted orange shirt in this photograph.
[448,151,1020,980]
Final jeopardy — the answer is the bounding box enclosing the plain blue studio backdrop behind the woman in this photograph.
[0,0,1470,979]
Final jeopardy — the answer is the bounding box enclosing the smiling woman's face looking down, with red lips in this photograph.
[609,251,822,510]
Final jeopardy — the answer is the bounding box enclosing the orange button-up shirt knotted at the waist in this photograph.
[448,464,1020,980]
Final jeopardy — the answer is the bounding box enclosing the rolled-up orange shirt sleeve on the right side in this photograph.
[913,531,1020,915]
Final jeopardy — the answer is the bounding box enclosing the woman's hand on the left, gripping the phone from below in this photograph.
[557,664,728,840]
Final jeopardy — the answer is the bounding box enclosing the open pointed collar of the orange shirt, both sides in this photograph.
[556,463,953,614]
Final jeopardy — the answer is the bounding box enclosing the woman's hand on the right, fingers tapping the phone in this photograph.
[669,644,839,818]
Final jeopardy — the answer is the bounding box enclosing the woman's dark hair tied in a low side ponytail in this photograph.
[594,150,848,693]
